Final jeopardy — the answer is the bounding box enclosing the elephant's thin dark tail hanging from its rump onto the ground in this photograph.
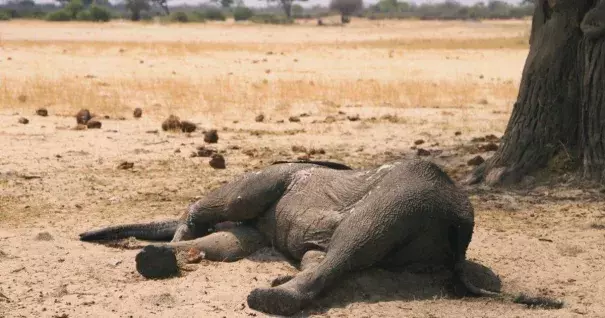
[449,222,500,297]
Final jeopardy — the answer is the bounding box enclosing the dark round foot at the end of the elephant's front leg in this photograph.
[135,245,179,278]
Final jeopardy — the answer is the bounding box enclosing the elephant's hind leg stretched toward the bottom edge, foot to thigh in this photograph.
[248,194,422,315]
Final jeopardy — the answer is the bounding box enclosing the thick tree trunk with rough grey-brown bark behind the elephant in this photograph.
[466,0,605,185]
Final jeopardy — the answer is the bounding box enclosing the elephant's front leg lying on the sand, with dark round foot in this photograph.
[135,226,266,278]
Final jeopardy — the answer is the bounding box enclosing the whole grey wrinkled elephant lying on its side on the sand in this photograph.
[80,160,492,315]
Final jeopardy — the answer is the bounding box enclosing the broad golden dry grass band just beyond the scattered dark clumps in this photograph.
[0,77,516,116]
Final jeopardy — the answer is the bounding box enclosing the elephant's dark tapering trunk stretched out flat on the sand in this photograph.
[80,220,180,242]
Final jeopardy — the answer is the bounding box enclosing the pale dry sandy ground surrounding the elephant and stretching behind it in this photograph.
[0,21,605,317]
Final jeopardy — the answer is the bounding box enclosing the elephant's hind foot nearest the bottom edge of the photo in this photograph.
[248,287,308,316]
